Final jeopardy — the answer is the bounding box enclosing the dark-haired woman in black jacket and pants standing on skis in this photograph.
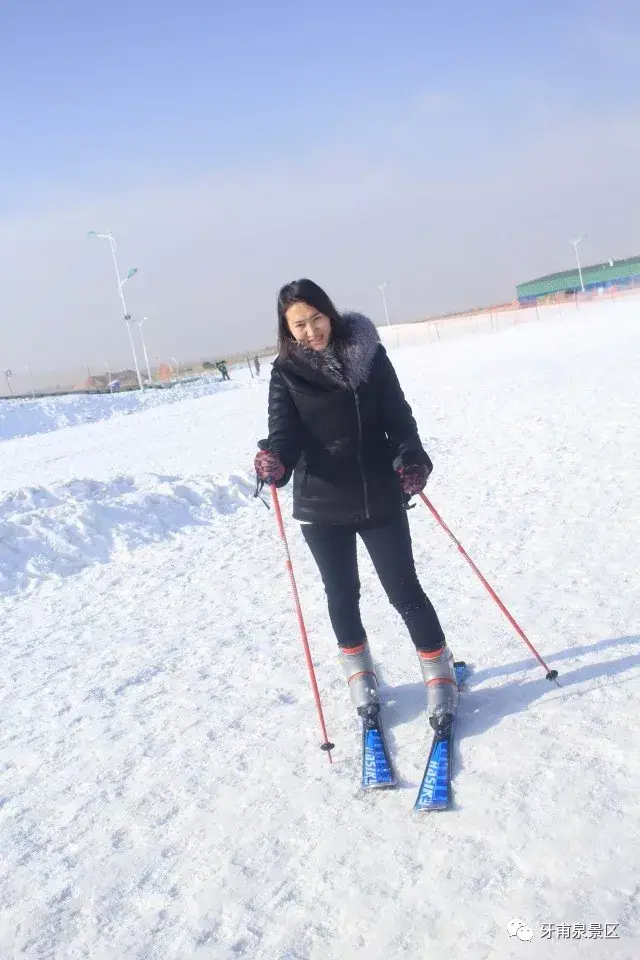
[255,280,457,726]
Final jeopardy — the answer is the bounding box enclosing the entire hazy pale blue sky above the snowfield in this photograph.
[0,0,640,382]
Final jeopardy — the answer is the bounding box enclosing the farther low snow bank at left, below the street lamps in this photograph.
[0,376,243,441]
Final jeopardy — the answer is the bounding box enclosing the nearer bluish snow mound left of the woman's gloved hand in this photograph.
[0,474,253,594]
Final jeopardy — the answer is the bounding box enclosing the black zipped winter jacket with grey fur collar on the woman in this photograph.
[261,313,432,524]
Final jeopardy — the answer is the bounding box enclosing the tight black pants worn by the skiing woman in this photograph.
[302,513,444,650]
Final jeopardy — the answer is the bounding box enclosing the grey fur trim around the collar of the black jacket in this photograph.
[280,311,380,390]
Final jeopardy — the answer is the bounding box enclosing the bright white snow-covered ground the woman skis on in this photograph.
[0,303,640,960]
